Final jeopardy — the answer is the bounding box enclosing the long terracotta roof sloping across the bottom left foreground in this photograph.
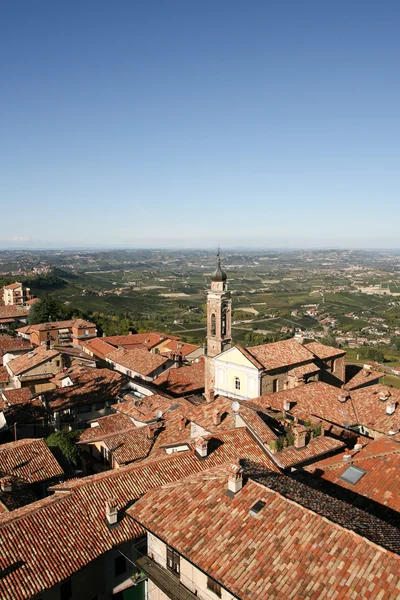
[0,430,276,600]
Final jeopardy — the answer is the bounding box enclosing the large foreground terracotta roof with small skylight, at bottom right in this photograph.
[128,466,400,600]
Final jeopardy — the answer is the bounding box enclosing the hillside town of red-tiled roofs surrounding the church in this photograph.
[0,253,400,600]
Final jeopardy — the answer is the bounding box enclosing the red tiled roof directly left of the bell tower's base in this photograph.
[153,358,205,396]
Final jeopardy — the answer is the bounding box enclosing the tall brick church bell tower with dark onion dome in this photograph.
[205,250,232,402]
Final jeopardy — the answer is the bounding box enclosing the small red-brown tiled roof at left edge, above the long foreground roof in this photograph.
[0,438,64,483]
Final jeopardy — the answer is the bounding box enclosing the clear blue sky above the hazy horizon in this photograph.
[0,0,400,248]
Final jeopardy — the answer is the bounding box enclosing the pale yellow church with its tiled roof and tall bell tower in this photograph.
[205,254,346,402]
